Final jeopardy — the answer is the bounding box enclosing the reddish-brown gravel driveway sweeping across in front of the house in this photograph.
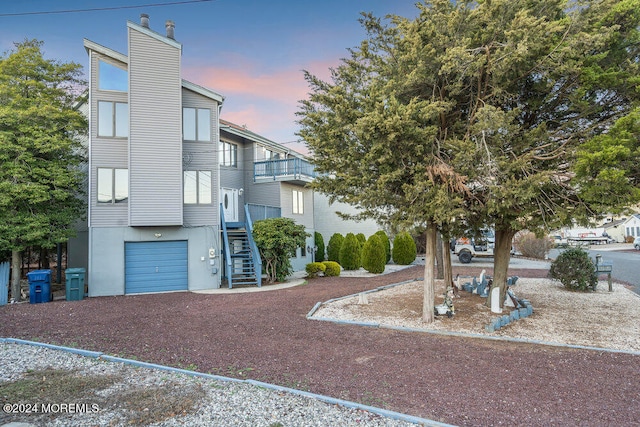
[0,267,640,426]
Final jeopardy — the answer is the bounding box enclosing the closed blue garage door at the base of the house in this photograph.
[124,241,188,294]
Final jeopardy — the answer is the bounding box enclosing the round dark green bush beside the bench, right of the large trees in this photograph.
[549,248,598,291]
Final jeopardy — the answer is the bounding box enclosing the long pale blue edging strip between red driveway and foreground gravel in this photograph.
[0,338,454,427]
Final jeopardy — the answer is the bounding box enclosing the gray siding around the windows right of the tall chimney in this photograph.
[180,88,220,227]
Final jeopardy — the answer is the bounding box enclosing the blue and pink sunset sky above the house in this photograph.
[0,0,417,151]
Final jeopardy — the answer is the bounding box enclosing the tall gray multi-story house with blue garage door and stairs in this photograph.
[79,15,324,296]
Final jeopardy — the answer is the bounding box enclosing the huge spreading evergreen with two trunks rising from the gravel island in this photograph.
[300,0,640,321]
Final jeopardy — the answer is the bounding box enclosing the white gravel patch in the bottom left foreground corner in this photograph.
[0,342,430,426]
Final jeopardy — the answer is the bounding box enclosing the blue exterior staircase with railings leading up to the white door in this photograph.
[220,204,262,289]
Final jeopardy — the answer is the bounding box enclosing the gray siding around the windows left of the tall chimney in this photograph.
[89,51,129,227]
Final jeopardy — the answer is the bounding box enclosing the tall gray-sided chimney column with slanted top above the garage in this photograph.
[129,27,183,226]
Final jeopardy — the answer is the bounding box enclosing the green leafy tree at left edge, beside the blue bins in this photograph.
[0,40,87,301]
